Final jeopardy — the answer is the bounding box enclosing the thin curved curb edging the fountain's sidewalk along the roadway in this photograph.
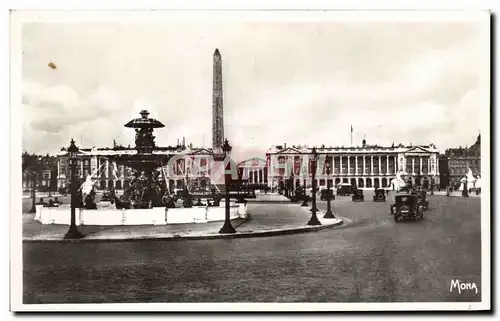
[23,217,344,243]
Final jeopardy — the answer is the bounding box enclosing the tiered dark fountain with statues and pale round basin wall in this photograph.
[35,110,247,225]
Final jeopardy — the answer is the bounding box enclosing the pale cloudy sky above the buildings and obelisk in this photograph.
[22,17,489,160]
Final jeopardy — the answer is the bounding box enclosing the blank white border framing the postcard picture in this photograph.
[10,11,491,311]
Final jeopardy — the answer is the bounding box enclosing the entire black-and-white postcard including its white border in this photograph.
[10,10,491,311]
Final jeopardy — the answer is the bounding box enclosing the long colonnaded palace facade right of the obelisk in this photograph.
[266,140,439,188]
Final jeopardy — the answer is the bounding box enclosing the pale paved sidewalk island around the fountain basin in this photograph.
[23,202,343,242]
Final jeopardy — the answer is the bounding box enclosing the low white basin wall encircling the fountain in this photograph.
[35,203,247,225]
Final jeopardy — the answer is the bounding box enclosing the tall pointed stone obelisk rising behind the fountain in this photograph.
[212,49,224,150]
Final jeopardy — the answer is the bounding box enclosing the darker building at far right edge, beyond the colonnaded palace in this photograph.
[445,134,481,185]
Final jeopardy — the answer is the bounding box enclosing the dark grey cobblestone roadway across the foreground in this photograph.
[23,192,482,303]
